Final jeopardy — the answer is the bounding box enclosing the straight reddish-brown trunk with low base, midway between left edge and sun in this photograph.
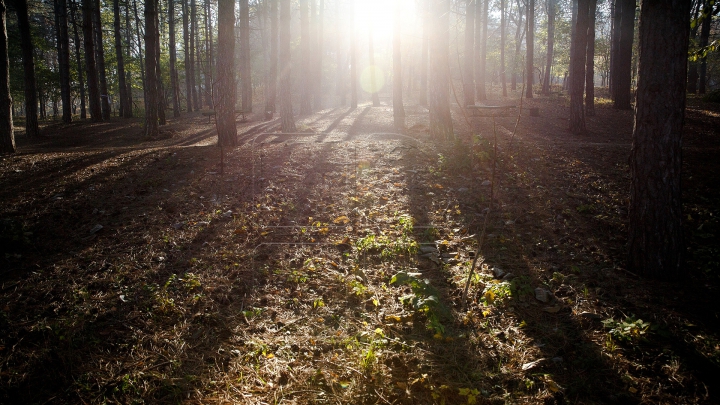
[215,0,239,146]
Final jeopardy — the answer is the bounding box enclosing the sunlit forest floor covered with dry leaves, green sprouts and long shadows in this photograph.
[0,91,720,404]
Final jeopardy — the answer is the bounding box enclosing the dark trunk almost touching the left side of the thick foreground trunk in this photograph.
[612,0,635,110]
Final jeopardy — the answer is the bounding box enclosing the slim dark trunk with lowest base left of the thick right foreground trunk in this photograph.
[570,0,591,135]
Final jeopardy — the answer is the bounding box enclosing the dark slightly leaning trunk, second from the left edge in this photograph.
[15,0,40,138]
